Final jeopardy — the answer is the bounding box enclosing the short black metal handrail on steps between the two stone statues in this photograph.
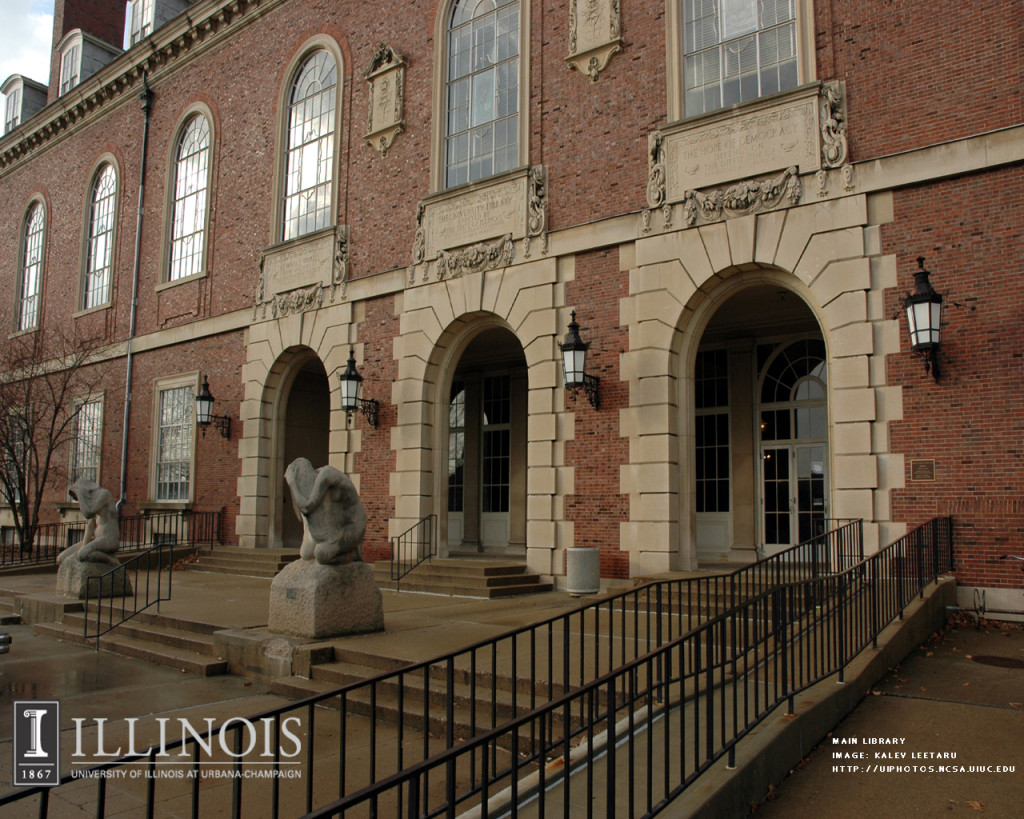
[84,542,174,649]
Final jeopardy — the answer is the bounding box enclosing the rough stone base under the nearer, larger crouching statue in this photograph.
[268,560,384,640]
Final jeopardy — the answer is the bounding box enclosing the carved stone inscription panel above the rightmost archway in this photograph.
[663,91,821,202]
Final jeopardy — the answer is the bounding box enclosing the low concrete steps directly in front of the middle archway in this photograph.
[372,558,552,598]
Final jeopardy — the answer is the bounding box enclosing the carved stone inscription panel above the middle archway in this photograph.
[422,176,527,259]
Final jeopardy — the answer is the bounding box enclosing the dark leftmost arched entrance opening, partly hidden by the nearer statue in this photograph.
[272,356,331,549]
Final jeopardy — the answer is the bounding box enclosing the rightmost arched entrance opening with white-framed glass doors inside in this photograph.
[690,278,829,563]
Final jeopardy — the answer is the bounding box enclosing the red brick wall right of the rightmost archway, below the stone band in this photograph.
[883,168,1024,586]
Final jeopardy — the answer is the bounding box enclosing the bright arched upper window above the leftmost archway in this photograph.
[282,49,338,242]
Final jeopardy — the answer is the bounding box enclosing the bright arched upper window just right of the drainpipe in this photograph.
[164,109,214,284]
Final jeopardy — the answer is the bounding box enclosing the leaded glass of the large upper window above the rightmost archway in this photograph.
[683,0,799,117]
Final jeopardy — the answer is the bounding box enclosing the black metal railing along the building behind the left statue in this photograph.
[0,510,222,568]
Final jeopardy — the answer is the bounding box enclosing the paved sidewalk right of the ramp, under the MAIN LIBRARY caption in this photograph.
[755,617,1024,819]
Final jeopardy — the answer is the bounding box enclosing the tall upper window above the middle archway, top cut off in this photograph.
[444,0,520,187]
